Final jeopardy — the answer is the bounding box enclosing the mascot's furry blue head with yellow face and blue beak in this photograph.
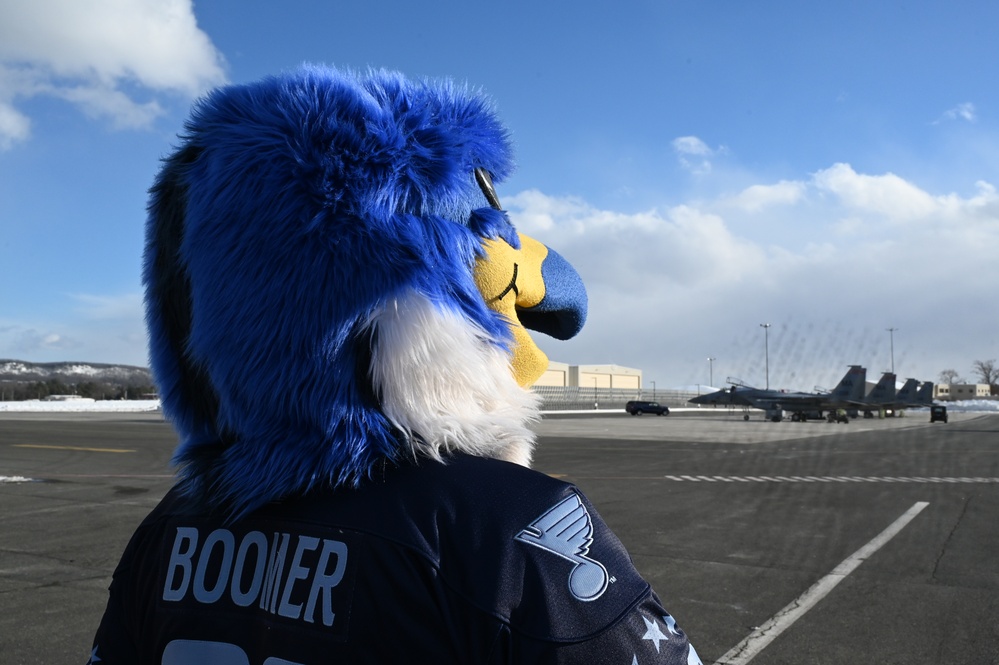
[144,67,586,517]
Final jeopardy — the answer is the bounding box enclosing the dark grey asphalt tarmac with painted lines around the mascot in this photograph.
[0,412,999,665]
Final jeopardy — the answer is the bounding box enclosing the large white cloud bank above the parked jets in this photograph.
[506,164,999,389]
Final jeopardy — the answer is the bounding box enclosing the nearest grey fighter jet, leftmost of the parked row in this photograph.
[688,365,867,422]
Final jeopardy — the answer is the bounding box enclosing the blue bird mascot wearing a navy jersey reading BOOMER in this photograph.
[91,66,700,665]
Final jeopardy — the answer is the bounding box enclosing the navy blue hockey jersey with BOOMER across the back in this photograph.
[90,455,700,665]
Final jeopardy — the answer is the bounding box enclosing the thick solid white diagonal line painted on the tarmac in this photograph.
[715,501,930,665]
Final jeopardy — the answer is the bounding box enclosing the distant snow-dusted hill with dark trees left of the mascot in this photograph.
[0,359,155,400]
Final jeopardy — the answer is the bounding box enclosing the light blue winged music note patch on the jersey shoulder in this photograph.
[514,494,609,602]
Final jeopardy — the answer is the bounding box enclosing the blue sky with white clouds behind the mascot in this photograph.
[0,0,999,389]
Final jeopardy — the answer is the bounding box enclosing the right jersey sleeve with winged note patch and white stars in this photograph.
[500,487,701,665]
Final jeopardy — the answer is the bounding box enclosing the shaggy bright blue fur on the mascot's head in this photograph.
[150,67,517,517]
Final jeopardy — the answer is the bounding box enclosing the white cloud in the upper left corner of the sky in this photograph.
[0,0,225,148]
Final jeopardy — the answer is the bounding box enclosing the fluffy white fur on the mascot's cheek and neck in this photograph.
[369,291,539,466]
